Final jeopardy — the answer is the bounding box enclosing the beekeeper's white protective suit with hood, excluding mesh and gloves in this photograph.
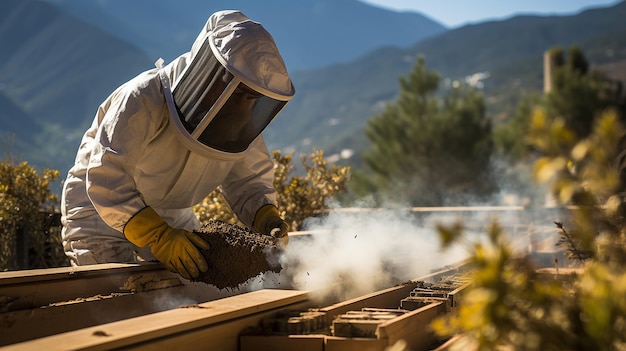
[61,11,294,265]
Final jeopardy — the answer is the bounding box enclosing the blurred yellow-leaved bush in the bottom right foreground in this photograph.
[433,222,577,351]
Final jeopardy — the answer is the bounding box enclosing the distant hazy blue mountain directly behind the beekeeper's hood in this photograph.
[47,0,446,71]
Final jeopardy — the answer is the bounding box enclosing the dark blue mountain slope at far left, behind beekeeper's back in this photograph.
[0,0,152,171]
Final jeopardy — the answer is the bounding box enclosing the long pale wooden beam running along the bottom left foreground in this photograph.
[1,290,308,351]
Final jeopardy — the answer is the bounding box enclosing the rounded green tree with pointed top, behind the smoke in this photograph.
[363,57,495,206]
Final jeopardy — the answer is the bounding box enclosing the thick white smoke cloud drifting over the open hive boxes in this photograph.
[266,210,467,301]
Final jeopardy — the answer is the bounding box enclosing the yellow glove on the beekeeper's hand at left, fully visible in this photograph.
[124,207,209,279]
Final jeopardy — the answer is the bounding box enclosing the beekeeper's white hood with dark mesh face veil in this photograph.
[165,11,295,155]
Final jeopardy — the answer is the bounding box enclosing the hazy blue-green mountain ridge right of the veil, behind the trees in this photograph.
[266,2,626,160]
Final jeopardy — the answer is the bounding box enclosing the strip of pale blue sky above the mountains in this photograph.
[361,0,621,28]
